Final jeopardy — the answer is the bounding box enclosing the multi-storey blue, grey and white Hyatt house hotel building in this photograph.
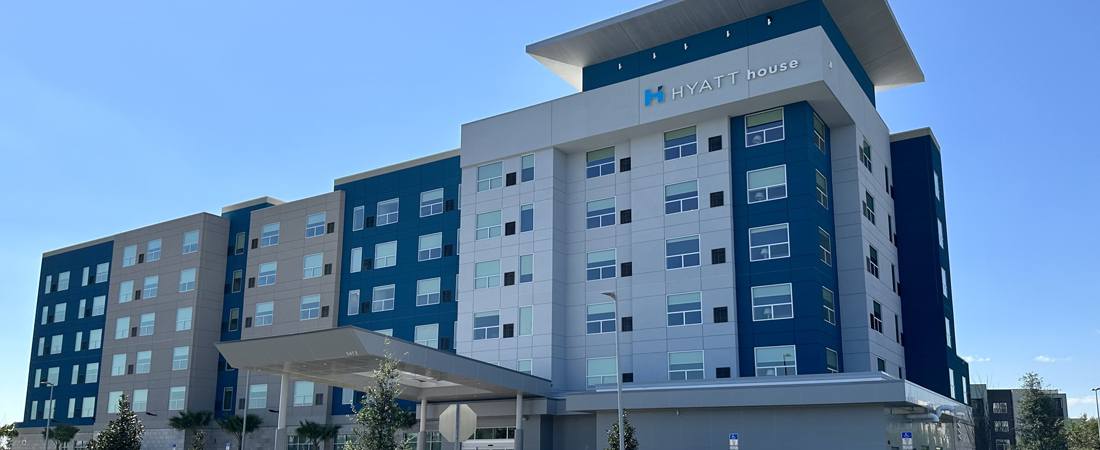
[23,0,972,450]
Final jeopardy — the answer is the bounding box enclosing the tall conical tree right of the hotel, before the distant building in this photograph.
[1016,372,1066,450]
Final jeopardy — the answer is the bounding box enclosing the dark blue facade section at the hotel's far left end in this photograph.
[21,241,114,427]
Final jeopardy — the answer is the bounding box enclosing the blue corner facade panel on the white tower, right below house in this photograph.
[729,102,843,376]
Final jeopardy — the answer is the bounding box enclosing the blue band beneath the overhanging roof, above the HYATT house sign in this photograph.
[582,0,875,105]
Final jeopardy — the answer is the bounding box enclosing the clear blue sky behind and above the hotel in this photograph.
[0,0,1100,422]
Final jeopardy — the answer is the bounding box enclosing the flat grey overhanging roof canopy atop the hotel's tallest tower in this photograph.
[527,0,924,91]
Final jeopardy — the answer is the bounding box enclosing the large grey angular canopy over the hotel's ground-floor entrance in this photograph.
[217,327,550,402]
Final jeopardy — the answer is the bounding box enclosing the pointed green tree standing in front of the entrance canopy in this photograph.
[347,339,416,450]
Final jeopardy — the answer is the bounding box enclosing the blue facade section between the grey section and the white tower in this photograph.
[332,156,462,414]
